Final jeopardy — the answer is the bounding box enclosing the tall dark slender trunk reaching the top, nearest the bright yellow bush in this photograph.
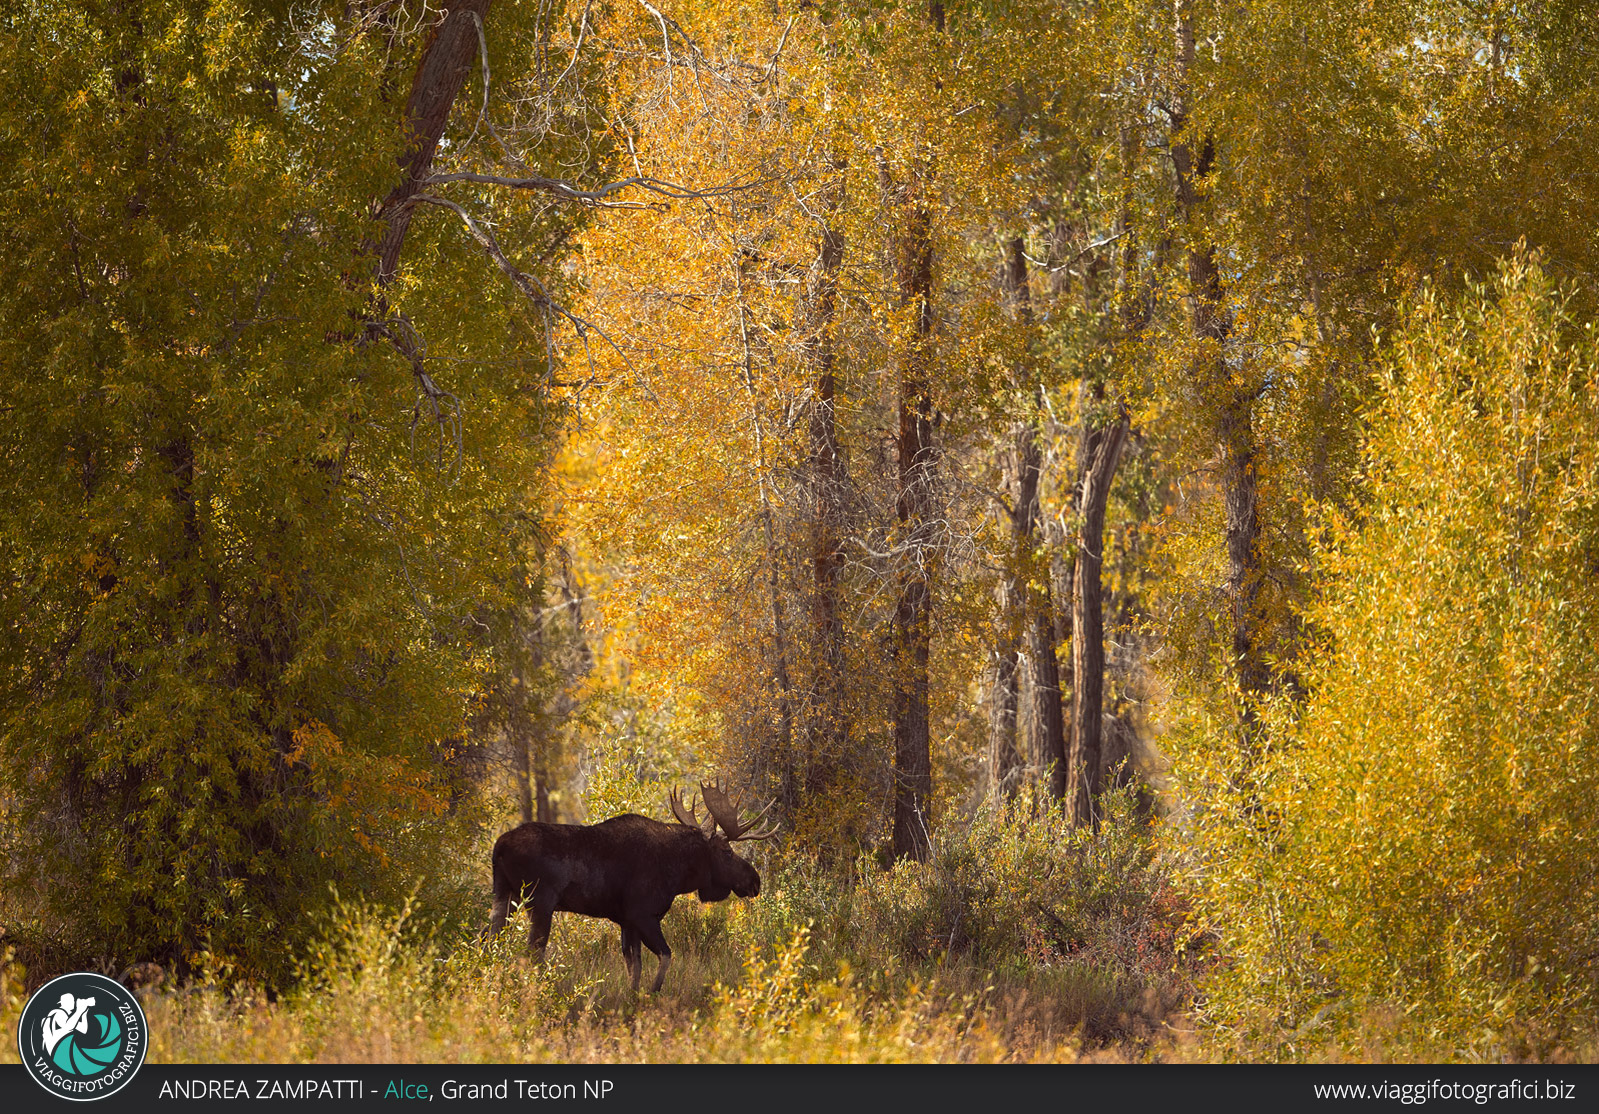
[1170,0,1271,728]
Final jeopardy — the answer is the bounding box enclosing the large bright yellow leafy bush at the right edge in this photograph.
[1196,261,1599,1058]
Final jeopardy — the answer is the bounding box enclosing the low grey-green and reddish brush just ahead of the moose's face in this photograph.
[709,783,1191,1042]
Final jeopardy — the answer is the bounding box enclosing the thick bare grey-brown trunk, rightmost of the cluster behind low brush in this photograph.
[1068,408,1127,825]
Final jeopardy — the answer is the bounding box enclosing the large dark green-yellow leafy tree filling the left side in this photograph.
[0,0,588,978]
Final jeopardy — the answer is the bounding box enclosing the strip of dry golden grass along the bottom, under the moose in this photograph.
[9,890,1599,1063]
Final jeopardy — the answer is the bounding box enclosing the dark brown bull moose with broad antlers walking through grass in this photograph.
[489,782,777,994]
